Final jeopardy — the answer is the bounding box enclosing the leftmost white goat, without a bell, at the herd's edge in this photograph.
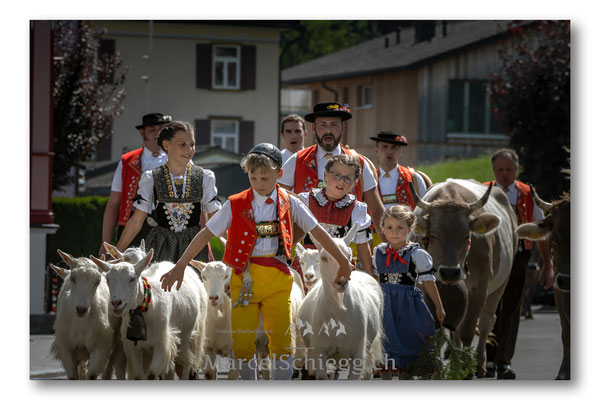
[50,250,125,379]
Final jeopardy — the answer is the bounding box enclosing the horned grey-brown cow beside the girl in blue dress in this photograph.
[411,179,517,378]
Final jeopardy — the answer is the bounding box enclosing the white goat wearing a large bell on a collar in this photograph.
[91,249,207,379]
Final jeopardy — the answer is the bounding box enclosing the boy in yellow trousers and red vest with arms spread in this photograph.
[161,143,352,380]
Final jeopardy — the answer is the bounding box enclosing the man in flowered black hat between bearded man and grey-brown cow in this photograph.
[370,131,427,210]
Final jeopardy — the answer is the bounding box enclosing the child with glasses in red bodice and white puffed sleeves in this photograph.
[298,154,372,274]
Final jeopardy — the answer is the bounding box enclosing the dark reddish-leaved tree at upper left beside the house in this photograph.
[52,21,129,190]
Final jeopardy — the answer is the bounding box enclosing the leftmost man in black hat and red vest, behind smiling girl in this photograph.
[98,113,171,255]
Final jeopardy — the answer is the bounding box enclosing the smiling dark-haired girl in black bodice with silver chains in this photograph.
[117,121,221,262]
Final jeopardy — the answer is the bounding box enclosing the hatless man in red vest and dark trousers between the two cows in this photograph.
[485,149,554,379]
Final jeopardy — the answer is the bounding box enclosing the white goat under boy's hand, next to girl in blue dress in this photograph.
[298,224,385,379]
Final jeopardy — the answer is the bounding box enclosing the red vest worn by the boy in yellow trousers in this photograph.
[223,185,293,274]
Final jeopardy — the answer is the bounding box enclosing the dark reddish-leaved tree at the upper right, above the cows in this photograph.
[490,21,571,199]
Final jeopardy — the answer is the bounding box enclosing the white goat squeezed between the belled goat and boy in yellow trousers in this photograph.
[190,260,239,380]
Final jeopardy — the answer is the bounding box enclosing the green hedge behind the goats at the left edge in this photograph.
[46,196,108,263]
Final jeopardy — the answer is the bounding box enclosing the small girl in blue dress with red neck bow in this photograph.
[373,205,446,379]
